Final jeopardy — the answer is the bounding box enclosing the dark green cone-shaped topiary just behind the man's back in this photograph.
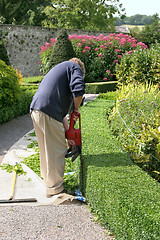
[48,29,76,71]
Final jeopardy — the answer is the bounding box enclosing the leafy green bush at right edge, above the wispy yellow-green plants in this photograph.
[116,44,160,85]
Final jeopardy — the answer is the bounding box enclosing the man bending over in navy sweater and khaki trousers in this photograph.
[30,58,85,197]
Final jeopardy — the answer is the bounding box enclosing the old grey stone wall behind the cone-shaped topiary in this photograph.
[0,24,111,77]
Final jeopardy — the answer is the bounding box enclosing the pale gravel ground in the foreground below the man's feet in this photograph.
[0,205,113,240]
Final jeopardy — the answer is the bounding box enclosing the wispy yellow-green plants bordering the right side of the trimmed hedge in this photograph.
[109,84,160,181]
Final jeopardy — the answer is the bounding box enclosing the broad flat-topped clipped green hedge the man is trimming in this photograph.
[81,99,160,240]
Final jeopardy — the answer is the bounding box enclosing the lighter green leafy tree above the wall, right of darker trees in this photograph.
[42,0,124,31]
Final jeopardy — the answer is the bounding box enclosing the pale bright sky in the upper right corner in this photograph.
[119,0,160,17]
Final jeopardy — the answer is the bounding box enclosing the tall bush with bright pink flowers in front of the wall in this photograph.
[40,33,147,83]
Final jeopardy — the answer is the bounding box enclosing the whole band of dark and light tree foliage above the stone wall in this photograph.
[0,0,124,31]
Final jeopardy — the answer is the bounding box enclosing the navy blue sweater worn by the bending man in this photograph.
[30,61,85,122]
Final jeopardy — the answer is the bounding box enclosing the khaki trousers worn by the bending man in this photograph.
[31,110,67,194]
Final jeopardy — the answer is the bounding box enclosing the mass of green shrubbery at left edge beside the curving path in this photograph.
[0,66,39,124]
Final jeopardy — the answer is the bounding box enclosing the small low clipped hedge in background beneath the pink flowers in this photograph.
[85,81,117,93]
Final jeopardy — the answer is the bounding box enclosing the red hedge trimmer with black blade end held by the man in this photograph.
[65,113,82,162]
